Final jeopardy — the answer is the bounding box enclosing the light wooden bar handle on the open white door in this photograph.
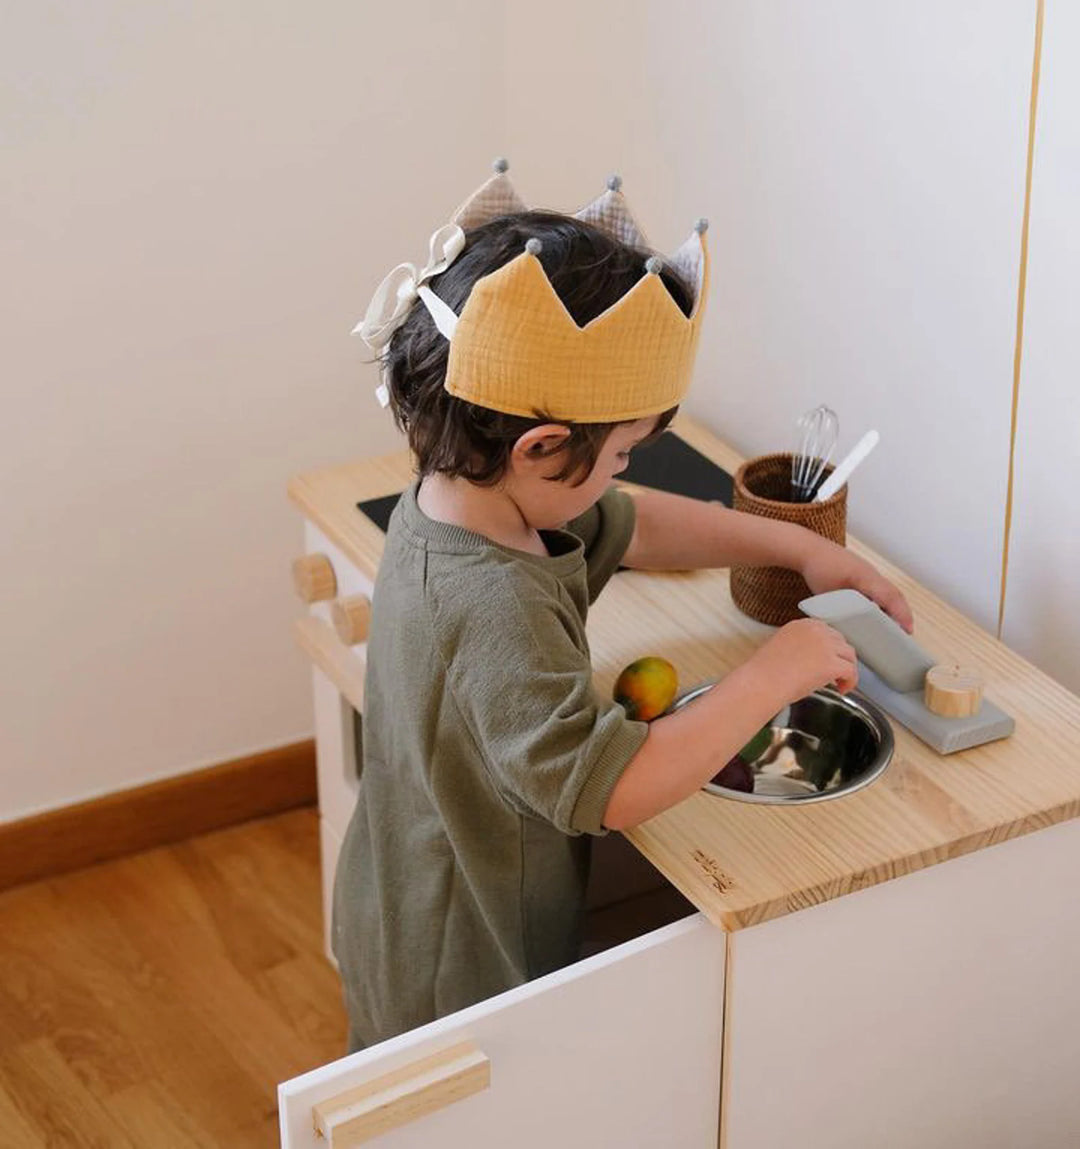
[311,1041,492,1149]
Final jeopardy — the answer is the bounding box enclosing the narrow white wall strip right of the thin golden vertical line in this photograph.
[1002,0,1080,691]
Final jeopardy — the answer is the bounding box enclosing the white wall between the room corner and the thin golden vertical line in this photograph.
[508,0,1035,638]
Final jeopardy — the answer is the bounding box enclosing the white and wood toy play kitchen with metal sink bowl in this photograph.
[279,416,1080,1149]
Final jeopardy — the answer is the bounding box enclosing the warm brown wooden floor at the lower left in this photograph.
[0,809,345,1149]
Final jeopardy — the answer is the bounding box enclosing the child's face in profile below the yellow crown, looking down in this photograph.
[506,415,656,531]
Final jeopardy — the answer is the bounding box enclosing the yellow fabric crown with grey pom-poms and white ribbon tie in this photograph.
[356,161,709,423]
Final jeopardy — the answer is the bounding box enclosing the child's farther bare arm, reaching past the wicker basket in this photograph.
[623,482,913,629]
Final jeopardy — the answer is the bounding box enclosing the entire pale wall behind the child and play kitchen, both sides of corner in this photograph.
[0,0,1080,819]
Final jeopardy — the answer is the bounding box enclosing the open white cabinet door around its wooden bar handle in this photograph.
[278,913,725,1149]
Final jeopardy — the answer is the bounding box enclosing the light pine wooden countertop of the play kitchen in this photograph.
[288,416,1080,930]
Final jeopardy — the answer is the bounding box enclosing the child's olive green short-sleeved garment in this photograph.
[333,484,647,1049]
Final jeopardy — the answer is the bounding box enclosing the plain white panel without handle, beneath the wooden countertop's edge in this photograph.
[724,818,1080,1149]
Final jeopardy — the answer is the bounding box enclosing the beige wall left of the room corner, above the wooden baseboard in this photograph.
[0,0,504,819]
